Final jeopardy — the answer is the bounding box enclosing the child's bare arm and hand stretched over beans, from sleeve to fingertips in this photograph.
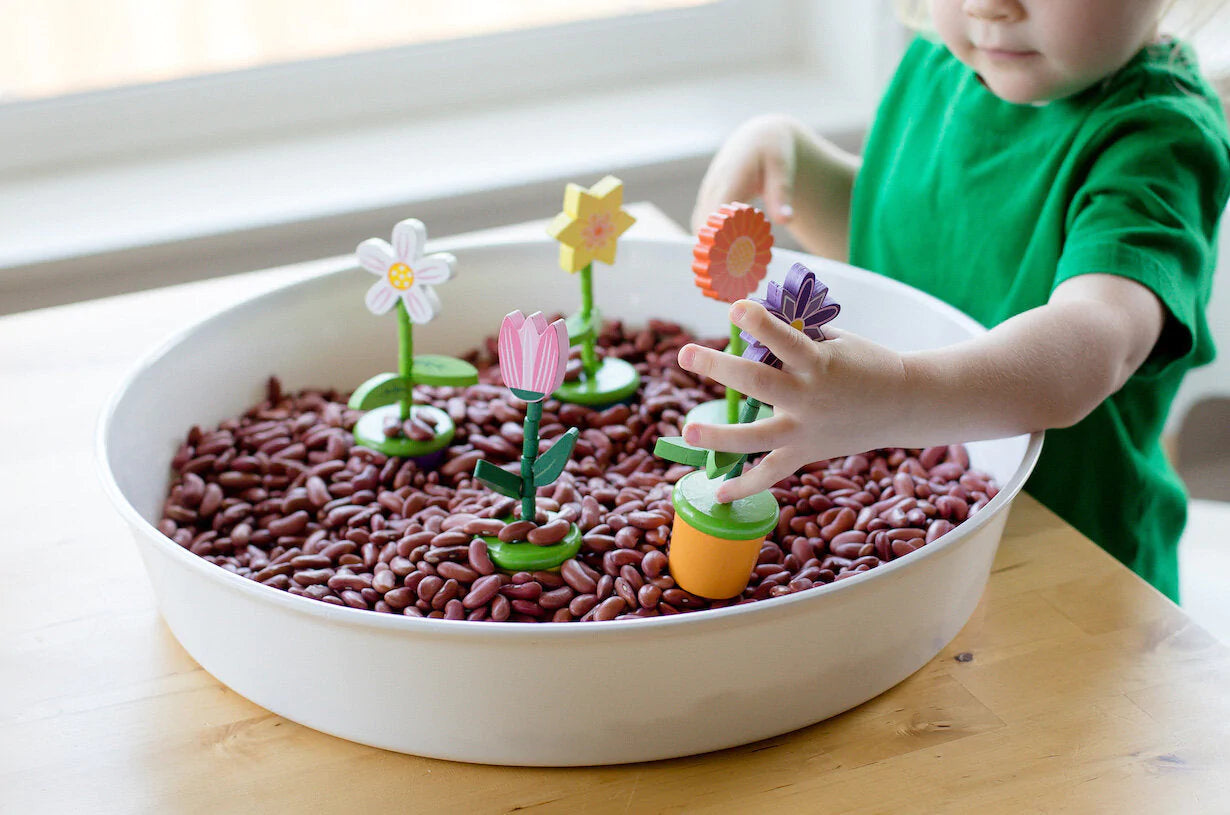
[679,274,1165,500]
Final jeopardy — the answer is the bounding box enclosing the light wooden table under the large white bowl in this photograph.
[0,205,1230,815]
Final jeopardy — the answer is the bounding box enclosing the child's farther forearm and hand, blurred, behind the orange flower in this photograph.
[692,116,862,261]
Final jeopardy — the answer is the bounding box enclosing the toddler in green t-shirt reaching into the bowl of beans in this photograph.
[679,0,1230,600]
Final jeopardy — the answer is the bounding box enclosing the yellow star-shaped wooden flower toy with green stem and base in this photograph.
[547,176,641,407]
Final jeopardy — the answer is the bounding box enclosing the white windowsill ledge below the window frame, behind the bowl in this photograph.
[0,63,875,312]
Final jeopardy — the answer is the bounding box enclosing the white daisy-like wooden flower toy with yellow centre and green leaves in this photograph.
[349,218,478,466]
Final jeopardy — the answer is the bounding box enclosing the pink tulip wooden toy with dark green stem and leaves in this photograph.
[474,311,581,572]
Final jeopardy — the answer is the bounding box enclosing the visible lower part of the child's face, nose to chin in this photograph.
[929,0,1165,103]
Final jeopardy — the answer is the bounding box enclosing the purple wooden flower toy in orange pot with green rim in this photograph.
[653,263,841,600]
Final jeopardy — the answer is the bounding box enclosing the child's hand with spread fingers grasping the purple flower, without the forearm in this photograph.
[679,300,910,502]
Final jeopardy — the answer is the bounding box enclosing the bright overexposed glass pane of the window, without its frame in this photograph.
[0,0,717,102]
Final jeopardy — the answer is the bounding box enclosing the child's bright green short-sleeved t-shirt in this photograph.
[850,38,1230,599]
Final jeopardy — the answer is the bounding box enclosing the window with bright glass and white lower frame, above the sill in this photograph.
[0,0,797,172]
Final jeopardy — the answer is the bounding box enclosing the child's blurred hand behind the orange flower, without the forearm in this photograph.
[691,116,802,232]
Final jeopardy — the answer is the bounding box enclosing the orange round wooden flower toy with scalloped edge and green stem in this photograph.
[686,203,772,424]
